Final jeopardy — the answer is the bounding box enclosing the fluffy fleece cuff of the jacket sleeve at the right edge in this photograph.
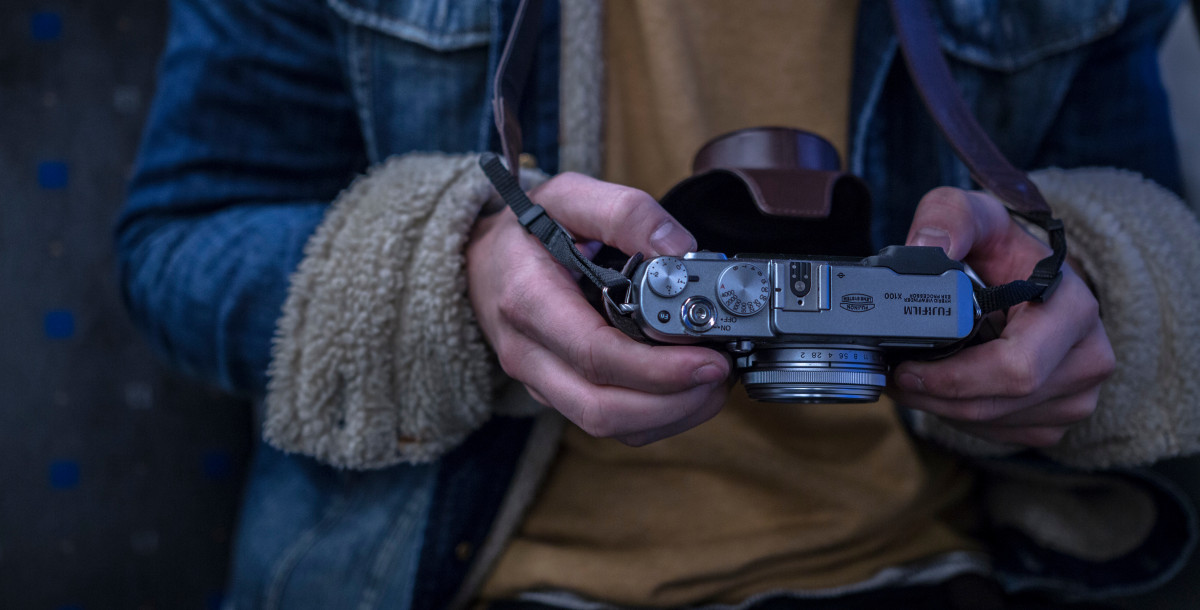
[913,168,1200,470]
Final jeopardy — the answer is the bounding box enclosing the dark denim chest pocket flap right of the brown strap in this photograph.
[937,0,1129,72]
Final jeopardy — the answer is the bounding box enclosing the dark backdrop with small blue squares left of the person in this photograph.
[0,0,250,610]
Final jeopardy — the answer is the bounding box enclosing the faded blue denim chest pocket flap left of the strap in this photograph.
[328,0,491,50]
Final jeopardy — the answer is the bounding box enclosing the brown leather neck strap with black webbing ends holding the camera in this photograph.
[479,0,1067,314]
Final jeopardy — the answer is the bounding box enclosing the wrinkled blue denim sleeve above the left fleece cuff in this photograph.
[116,0,366,394]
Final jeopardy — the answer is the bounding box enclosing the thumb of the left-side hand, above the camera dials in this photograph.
[529,173,696,256]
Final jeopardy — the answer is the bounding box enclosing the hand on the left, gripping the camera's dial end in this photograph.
[467,173,731,445]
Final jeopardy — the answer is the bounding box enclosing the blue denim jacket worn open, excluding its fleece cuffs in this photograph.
[116,0,1182,608]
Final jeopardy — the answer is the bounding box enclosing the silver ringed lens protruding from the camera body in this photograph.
[736,345,887,402]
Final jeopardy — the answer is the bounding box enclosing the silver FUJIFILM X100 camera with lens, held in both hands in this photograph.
[606,246,982,402]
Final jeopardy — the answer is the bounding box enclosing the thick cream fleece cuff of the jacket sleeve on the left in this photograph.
[263,154,498,468]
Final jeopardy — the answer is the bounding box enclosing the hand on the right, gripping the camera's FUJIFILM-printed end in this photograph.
[892,187,1116,447]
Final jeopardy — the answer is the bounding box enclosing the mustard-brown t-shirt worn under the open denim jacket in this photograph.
[484,0,978,606]
